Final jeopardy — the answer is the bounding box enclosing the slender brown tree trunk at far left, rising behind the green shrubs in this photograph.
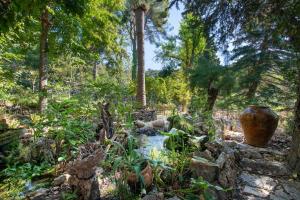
[39,8,50,112]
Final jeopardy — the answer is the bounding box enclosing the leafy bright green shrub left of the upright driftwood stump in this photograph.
[33,99,95,159]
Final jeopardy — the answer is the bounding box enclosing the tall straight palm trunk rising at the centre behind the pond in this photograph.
[135,6,146,107]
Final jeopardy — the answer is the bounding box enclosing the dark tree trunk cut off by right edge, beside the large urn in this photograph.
[289,65,300,173]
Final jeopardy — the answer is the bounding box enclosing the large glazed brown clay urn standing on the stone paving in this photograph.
[240,106,279,147]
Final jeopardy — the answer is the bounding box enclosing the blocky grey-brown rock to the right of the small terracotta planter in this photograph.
[190,157,218,182]
